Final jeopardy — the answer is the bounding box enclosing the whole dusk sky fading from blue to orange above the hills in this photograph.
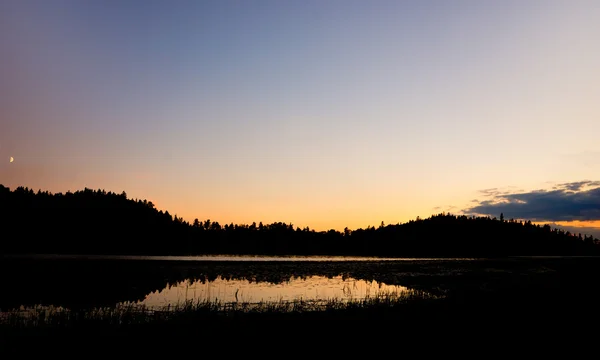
[0,0,600,237]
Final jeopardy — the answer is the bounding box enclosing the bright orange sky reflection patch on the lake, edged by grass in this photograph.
[129,276,407,307]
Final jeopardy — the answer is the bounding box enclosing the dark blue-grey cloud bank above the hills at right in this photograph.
[463,180,600,222]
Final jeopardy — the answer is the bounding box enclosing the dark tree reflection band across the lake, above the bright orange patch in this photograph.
[0,259,597,310]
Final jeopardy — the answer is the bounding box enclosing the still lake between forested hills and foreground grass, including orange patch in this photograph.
[0,255,599,311]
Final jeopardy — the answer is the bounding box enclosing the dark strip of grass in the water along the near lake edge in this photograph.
[0,290,443,329]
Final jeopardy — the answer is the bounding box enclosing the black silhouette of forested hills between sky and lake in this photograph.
[0,185,600,257]
